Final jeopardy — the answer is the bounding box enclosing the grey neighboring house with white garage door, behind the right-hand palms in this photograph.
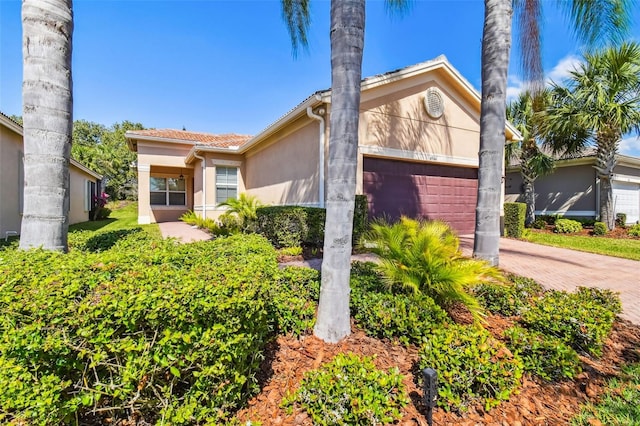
[505,149,640,224]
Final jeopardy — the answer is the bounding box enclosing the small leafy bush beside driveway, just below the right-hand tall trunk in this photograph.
[473,275,543,316]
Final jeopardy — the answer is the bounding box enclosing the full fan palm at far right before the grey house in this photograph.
[545,42,640,229]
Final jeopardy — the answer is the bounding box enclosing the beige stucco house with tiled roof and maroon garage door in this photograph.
[126,56,520,233]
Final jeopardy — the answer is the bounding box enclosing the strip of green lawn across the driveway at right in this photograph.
[524,231,640,260]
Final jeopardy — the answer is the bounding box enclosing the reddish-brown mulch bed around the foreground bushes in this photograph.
[238,315,640,426]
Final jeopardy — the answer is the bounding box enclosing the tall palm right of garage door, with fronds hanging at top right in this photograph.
[473,0,634,265]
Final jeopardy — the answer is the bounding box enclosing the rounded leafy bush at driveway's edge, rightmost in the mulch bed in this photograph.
[522,291,615,356]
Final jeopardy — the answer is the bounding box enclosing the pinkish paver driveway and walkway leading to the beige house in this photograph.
[158,222,640,324]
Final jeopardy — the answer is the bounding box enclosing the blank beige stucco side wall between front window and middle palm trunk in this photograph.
[245,116,320,206]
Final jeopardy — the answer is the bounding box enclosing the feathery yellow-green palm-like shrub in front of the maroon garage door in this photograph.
[363,217,503,321]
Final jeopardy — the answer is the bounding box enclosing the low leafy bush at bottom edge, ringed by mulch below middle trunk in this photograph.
[283,353,409,426]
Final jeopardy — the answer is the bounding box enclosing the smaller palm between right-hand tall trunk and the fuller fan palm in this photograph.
[505,91,554,226]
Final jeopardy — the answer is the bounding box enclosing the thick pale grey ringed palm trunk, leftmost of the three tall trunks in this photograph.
[20,0,73,251]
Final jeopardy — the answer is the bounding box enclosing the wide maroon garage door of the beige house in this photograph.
[362,157,478,233]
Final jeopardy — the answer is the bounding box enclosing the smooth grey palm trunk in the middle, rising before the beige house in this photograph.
[314,0,365,342]
